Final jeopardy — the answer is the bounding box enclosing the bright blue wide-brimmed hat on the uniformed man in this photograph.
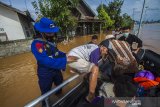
[34,17,59,33]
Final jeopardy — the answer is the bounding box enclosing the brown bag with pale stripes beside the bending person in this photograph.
[109,40,138,73]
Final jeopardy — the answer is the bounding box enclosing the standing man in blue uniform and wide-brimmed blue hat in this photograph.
[31,17,67,105]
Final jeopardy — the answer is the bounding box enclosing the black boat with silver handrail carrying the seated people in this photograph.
[25,45,160,107]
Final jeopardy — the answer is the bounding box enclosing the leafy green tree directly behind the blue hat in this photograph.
[32,0,78,36]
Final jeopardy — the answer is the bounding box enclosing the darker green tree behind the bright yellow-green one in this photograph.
[97,0,133,29]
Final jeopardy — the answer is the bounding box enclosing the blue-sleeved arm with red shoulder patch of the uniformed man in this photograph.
[31,42,67,69]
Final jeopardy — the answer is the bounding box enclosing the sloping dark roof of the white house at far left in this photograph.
[0,1,34,21]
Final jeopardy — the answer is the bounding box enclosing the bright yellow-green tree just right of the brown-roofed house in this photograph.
[97,6,114,30]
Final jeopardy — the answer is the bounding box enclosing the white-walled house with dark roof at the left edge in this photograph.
[0,2,34,41]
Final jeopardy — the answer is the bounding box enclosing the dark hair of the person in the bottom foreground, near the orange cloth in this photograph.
[113,75,137,98]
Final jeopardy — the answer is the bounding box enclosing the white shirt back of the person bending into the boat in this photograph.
[68,44,98,61]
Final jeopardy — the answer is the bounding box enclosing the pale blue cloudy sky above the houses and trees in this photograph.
[0,0,160,20]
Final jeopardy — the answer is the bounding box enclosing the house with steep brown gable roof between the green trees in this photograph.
[71,0,103,35]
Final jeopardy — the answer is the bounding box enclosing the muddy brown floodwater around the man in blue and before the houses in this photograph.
[0,35,104,107]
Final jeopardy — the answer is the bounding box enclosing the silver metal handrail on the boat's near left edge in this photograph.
[24,74,79,107]
